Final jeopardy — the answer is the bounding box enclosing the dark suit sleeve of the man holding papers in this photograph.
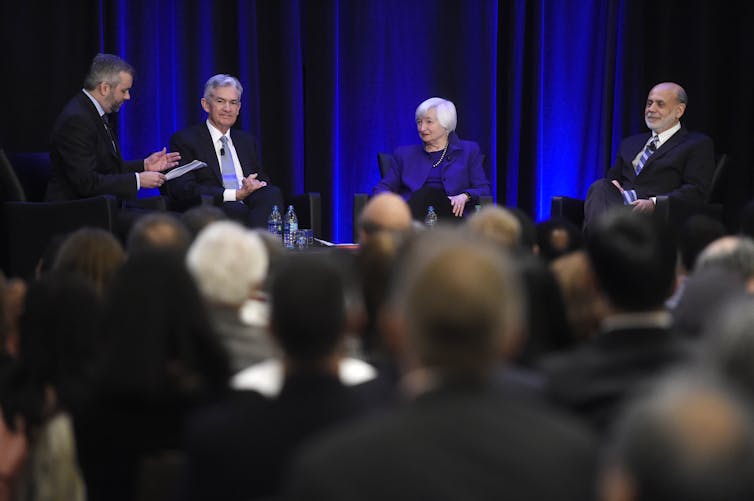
[51,108,143,199]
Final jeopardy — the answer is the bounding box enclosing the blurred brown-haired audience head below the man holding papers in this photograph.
[52,228,126,294]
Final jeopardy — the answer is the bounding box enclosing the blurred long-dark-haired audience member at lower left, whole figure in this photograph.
[0,272,101,501]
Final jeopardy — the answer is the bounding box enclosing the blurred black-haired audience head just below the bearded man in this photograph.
[587,210,676,312]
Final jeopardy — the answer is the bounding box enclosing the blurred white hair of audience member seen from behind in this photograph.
[186,221,269,306]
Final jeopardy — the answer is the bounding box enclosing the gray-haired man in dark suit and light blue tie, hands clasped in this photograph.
[166,74,283,228]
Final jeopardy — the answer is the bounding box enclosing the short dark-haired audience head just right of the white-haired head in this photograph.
[270,254,346,367]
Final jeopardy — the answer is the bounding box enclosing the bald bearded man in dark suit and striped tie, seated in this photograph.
[584,82,715,229]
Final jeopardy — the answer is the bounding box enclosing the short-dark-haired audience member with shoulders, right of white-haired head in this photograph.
[186,254,365,501]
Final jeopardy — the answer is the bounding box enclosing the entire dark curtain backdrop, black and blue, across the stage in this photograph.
[0,0,754,241]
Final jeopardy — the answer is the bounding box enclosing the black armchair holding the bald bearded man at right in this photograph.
[550,153,730,227]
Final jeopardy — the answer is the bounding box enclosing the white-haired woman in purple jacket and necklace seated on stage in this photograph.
[374,97,491,219]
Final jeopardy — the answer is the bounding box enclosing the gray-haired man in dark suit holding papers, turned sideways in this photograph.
[46,54,180,201]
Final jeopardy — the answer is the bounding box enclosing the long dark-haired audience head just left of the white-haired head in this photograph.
[97,251,230,403]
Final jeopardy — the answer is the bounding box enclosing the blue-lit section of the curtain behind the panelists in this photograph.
[99,0,628,241]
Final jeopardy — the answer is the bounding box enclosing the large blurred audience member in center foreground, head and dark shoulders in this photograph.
[287,229,595,501]
